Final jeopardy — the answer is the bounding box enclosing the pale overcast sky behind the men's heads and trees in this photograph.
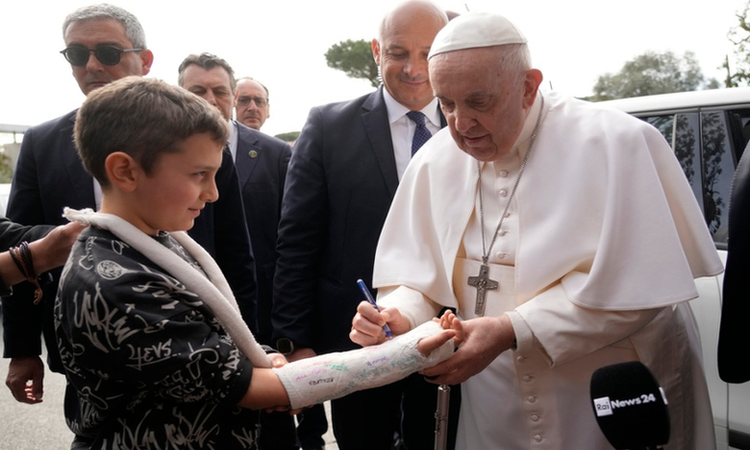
[0,0,748,141]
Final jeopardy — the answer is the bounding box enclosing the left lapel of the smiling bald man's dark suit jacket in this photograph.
[362,86,398,195]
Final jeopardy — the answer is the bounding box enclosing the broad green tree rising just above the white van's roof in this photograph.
[590,51,718,101]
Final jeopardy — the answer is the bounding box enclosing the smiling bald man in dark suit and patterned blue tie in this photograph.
[272,1,456,450]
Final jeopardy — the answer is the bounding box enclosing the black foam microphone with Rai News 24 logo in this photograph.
[591,361,670,450]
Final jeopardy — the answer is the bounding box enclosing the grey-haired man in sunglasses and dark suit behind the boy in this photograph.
[3,5,256,403]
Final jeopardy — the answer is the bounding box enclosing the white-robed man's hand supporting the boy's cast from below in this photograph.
[421,315,514,384]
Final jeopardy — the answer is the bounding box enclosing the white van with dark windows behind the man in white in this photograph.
[602,88,750,450]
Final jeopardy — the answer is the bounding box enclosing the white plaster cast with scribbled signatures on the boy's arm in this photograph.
[273,321,454,409]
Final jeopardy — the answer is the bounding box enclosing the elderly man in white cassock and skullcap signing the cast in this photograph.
[351,13,723,450]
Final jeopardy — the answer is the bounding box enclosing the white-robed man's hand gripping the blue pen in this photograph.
[349,301,411,347]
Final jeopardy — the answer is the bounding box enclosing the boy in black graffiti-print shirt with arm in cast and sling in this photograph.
[55,77,457,449]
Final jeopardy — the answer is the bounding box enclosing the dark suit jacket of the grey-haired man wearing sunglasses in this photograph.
[3,111,256,370]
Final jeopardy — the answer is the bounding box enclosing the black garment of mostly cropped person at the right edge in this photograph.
[718,144,750,383]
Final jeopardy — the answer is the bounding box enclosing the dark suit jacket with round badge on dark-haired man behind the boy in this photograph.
[235,123,292,345]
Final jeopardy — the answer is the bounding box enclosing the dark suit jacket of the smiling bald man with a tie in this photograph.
[272,87,445,353]
